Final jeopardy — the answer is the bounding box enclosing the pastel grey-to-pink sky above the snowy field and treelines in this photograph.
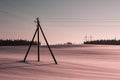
[0,0,120,44]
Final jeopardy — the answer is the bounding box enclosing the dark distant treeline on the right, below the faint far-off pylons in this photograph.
[84,40,120,45]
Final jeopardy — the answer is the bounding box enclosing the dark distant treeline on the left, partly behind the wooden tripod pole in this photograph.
[0,39,37,46]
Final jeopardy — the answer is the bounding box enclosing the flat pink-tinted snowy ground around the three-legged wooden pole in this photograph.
[0,46,120,80]
